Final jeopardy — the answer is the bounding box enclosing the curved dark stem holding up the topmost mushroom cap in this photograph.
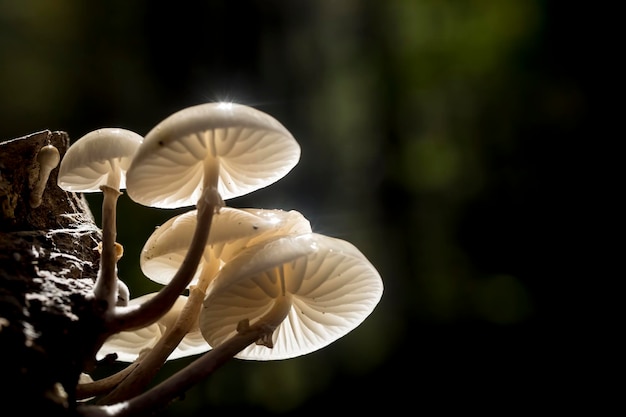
[103,186,223,334]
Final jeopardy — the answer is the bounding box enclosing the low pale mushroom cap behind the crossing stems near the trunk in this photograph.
[96,293,211,362]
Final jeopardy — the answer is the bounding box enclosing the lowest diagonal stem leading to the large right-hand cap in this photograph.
[77,295,291,417]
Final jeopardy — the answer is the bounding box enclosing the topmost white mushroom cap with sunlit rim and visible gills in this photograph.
[127,102,300,208]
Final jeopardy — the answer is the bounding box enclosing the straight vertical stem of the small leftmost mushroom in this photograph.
[94,185,122,312]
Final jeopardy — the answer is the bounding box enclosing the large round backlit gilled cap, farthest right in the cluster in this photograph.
[200,233,383,360]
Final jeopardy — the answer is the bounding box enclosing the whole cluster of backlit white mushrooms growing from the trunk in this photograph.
[58,102,383,415]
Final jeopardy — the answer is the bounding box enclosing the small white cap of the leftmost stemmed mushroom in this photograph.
[57,128,143,193]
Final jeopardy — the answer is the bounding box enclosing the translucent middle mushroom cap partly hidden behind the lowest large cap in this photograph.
[140,207,311,285]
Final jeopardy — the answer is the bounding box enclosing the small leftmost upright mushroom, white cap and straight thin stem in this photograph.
[57,128,143,311]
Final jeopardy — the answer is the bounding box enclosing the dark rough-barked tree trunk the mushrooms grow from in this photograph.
[0,131,101,416]
